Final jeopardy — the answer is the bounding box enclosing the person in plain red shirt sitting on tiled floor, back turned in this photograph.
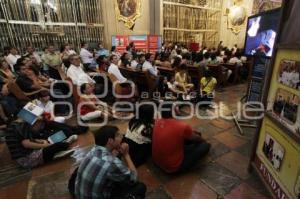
[152,103,210,173]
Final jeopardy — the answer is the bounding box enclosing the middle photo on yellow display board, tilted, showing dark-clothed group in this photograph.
[268,89,300,138]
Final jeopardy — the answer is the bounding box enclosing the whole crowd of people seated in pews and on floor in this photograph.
[0,43,244,198]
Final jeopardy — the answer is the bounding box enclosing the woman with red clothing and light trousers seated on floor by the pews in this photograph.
[79,83,113,121]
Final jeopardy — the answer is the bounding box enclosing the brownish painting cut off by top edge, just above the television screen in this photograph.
[252,0,282,14]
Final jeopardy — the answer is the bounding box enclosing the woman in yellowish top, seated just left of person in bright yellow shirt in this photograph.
[175,64,194,94]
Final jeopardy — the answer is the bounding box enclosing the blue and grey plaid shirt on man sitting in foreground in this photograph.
[75,146,137,199]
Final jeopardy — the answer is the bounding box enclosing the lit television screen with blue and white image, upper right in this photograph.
[245,9,280,57]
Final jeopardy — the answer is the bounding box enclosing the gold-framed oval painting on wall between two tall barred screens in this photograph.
[114,0,141,29]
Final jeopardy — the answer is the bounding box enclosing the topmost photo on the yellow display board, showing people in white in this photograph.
[278,59,300,90]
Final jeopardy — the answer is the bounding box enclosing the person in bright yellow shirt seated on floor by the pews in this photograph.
[198,70,217,105]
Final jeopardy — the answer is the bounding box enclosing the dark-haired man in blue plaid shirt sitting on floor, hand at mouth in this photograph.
[74,126,147,199]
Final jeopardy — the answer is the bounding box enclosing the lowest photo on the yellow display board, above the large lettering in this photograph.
[262,133,284,171]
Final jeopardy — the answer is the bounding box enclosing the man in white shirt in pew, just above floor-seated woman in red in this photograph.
[67,55,95,86]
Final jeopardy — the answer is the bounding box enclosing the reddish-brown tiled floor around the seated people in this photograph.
[0,85,270,199]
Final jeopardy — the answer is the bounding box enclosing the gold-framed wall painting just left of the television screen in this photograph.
[226,0,247,34]
